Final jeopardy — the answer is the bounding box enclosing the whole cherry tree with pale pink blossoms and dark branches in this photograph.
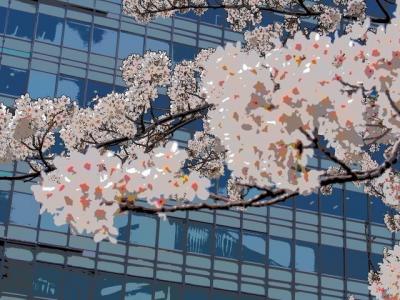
[0,0,400,299]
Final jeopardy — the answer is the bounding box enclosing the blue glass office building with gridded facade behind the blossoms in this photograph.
[0,0,397,300]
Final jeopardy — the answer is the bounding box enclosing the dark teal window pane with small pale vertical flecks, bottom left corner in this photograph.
[32,264,63,299]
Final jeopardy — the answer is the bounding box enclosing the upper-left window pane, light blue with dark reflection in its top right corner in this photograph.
[64,20,90,51]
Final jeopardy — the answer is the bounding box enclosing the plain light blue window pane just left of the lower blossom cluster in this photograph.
[10,192,40,227]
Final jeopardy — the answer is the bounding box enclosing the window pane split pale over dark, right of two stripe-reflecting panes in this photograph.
[242,231,265,264]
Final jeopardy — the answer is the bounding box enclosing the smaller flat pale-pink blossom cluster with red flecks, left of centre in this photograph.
[32,142,210,243]
